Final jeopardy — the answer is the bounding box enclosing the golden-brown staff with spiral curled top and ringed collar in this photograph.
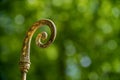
[20,19,56,80]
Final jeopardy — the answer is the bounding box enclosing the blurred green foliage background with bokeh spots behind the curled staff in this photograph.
[0,0,120,80]
